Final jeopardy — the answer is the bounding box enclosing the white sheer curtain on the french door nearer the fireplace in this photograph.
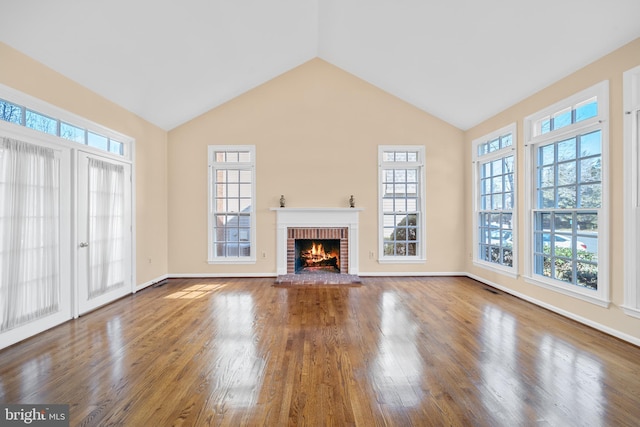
[88,158,125,299]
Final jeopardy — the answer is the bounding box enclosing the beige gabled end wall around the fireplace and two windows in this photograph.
[169,59,465,274]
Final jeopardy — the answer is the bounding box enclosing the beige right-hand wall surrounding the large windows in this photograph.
[464,39,640,340]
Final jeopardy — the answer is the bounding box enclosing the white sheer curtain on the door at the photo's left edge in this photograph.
[0,137,60,332]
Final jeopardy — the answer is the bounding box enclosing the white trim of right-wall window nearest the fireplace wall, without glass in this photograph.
[471,123,519,278]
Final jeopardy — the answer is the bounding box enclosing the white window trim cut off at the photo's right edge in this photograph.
[622,66,640,318]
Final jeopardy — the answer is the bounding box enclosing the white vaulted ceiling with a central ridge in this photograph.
[0,0,640,130]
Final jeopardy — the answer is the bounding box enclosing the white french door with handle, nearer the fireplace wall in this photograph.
[76,151,133,314]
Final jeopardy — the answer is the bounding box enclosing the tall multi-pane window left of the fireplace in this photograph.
[209,146,255,262]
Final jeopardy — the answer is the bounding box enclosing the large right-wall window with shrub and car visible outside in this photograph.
[525,82,609,305]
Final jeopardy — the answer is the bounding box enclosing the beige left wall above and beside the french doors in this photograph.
[0,43,168,284]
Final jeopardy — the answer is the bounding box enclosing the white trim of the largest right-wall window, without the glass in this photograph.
[523,80,611,307]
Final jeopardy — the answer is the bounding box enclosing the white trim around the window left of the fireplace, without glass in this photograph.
[207,145,257,264]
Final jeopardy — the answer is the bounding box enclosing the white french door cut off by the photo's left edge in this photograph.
[0,134,71,348]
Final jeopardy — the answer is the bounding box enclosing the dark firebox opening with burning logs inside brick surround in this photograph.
[295,239,340,274]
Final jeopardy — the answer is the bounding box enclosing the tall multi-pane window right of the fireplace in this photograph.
[378,146,425,262]
